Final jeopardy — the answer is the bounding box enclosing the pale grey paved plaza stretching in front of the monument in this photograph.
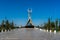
[0,28,60,40]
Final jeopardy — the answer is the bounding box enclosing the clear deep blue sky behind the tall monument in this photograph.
[0,0,60,25]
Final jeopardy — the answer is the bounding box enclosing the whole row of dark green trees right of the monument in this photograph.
[44,18,60,31]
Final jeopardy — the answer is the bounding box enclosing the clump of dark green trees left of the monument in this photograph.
[0,20,16,32]
